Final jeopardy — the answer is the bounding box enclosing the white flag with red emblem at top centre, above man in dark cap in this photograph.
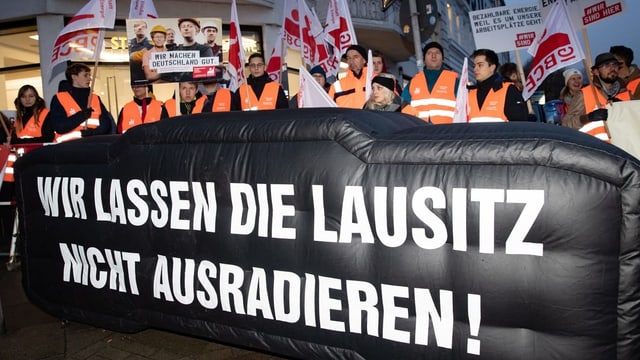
[324,0,358,59]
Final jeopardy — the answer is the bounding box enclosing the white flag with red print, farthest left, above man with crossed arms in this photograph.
[46,0,116,77]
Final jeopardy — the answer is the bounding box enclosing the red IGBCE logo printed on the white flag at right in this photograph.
[525,33,577,92]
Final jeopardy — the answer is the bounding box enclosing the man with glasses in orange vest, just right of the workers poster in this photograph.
[236,53,289,111]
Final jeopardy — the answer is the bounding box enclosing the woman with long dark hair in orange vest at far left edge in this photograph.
[11,85,53,144]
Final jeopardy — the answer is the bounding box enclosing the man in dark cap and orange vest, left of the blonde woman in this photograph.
[329,45,376,109]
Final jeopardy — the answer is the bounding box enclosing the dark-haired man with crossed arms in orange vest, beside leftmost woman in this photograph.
[45,63,115,142]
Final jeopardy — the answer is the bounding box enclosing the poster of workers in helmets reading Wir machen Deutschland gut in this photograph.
[127,17,223,84]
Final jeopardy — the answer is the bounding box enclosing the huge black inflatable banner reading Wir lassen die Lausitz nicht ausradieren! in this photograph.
[16,109,640,359]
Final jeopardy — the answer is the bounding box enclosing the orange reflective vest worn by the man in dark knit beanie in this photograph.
[409,70,458,124]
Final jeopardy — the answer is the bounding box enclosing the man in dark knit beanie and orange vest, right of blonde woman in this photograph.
[402,41,466,124]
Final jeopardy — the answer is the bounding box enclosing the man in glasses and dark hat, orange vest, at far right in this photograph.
[562,53,631,129]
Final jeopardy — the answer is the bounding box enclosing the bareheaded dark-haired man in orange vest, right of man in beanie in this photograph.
[468,49,529,122]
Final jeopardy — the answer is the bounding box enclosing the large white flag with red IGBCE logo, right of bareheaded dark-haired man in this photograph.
[522,1,584,100]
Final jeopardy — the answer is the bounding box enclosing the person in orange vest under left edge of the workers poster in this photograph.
[118,85,162,134]
